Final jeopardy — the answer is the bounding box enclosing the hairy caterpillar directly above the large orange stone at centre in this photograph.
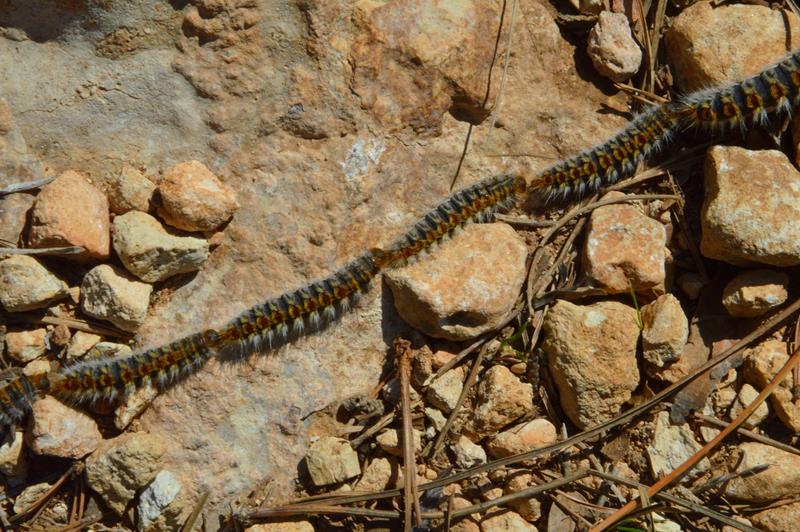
[386,175,527,268]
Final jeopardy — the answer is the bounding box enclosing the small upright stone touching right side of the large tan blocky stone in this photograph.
[642,294,689,368]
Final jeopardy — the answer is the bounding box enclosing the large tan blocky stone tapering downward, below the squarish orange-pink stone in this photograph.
[542,301,639,429]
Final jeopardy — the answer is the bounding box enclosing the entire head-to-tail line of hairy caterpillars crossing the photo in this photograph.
[0,46,800,426]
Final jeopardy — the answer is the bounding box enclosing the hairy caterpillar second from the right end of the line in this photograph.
[532,104,678,203]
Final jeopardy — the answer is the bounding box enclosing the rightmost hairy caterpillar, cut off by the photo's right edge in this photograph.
[677,50,800,134]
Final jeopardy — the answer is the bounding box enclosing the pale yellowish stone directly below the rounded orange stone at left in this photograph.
[114,211,208,283]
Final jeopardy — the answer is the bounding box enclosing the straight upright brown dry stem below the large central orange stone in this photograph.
[394,338,422,532]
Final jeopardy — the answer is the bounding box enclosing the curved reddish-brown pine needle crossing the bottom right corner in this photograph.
[592,349,800,532]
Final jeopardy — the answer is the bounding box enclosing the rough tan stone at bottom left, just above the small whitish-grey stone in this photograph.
[86,432,167,515]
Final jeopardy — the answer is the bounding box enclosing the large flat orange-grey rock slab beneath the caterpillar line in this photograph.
[0,0,627,529]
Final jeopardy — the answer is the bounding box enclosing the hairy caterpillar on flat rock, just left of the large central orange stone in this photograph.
[219,249,386,355]
